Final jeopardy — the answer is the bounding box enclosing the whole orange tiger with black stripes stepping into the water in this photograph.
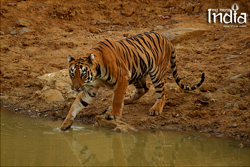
[60,32,205,131]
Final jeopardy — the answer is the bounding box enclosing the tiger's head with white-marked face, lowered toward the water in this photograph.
[68,53,95,91]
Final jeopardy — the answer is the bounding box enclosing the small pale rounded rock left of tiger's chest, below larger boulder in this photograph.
[40,89,64,102]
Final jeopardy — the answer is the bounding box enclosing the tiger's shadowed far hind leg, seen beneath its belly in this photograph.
[124,78,149,105]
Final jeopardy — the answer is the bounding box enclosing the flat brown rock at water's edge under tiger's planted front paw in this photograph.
[95,115,137,132]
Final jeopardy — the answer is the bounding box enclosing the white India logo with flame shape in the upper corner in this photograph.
[208,3,247,27]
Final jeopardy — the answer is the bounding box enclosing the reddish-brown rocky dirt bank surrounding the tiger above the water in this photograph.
[0,0,250,143]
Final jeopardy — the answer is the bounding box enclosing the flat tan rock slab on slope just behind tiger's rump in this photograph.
[162,28,208,43]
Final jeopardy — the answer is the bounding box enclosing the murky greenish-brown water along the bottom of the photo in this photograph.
[1,110,250,166]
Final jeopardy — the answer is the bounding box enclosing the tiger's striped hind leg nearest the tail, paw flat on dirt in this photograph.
[149,78,166,116]
